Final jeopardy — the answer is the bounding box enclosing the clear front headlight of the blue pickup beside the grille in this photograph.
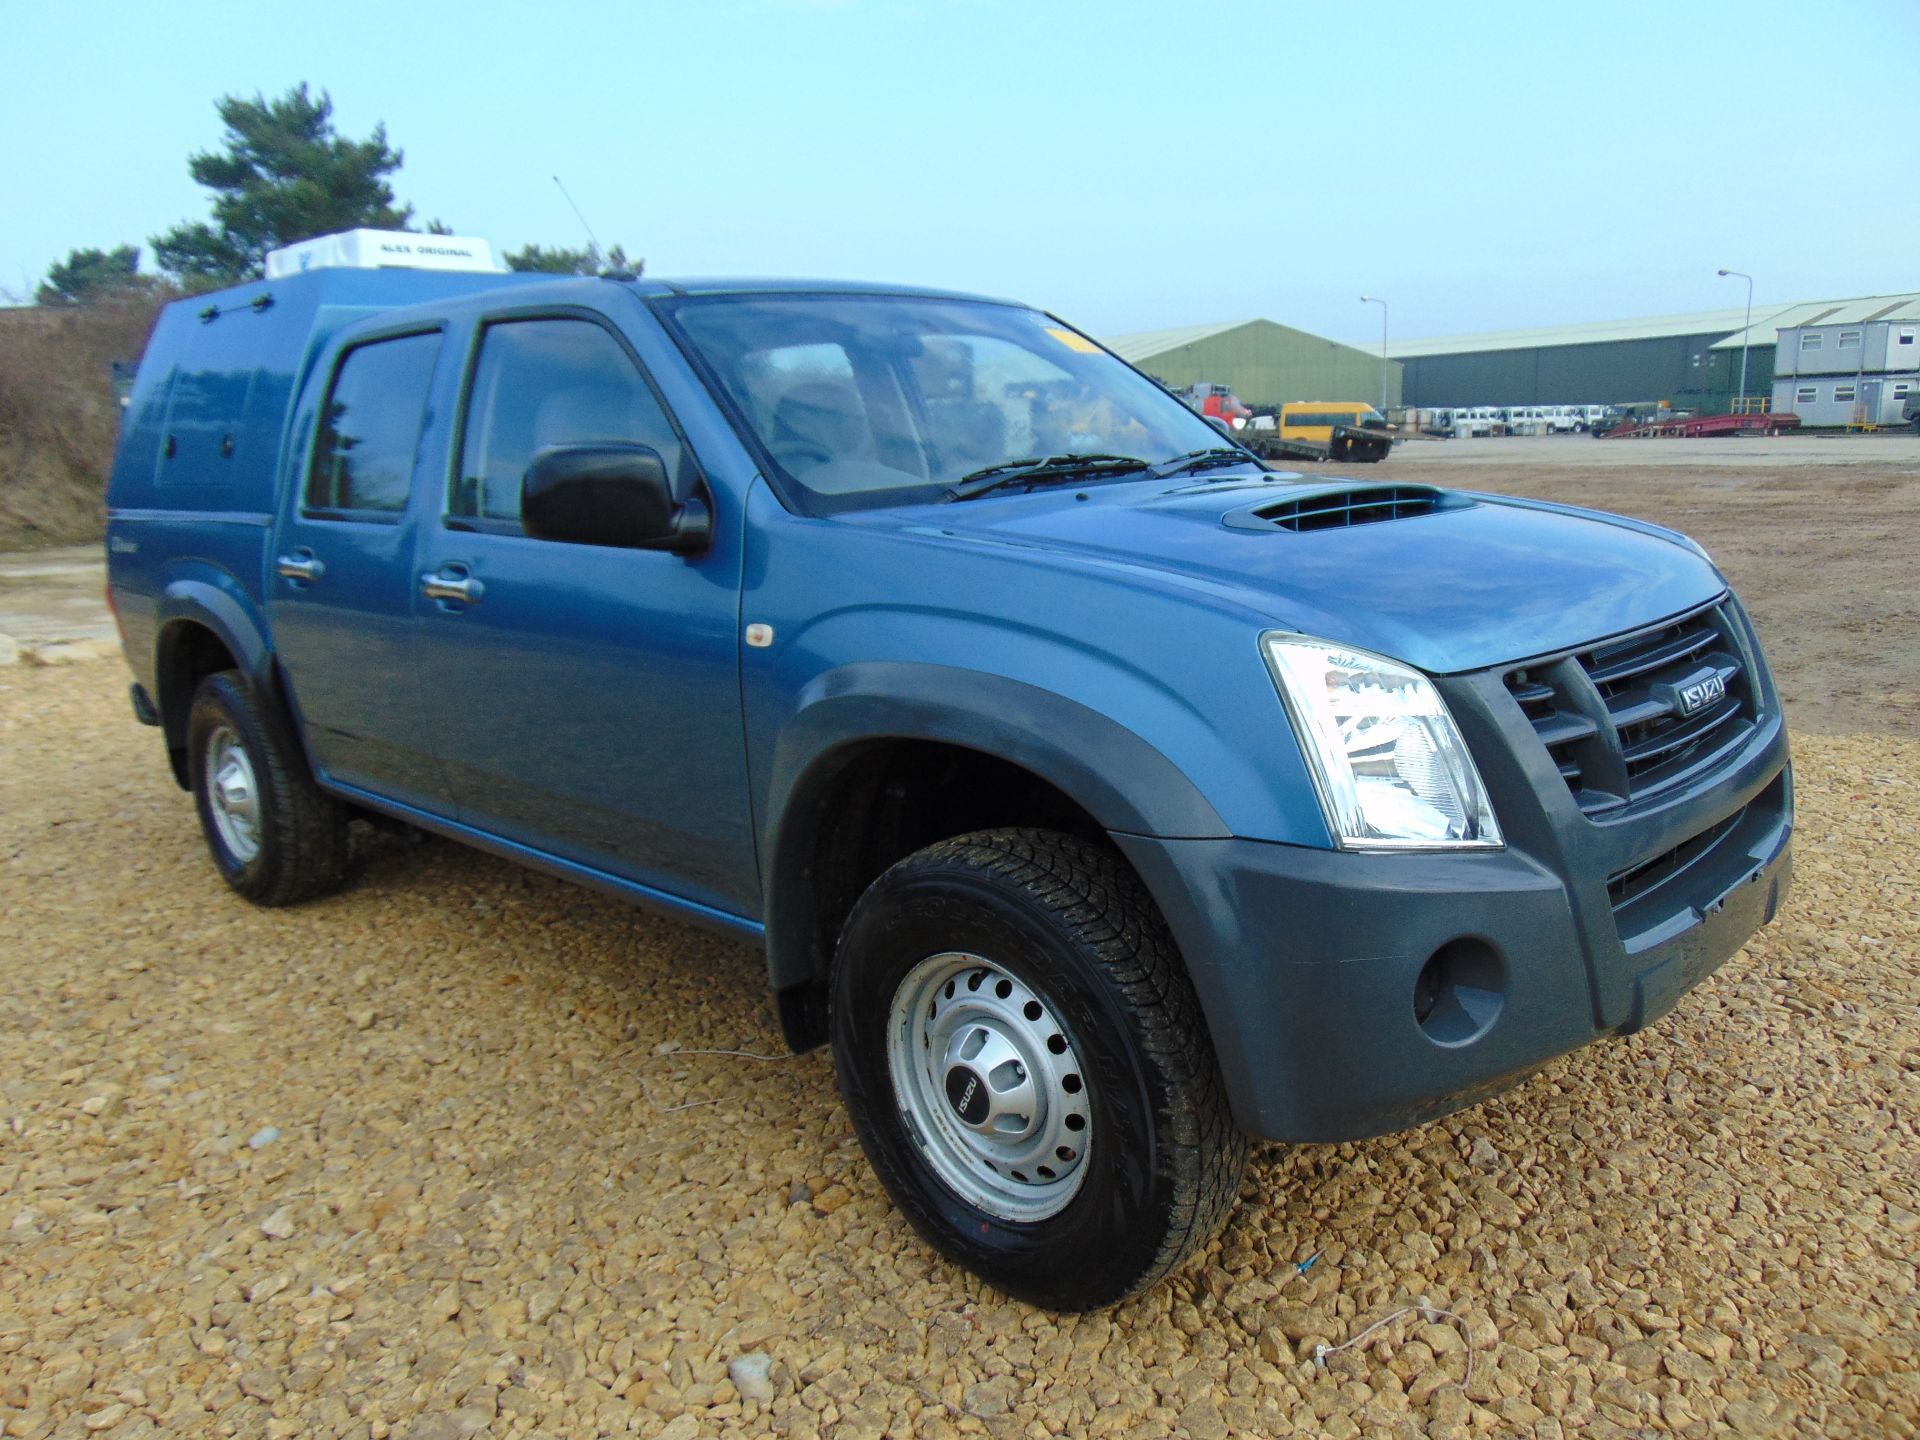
[1261,634,1501,851]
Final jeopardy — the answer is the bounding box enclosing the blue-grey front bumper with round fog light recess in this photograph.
[1114,606,1793,1140]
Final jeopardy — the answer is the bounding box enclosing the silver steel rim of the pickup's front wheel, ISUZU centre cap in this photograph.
[887,950,1092,1223]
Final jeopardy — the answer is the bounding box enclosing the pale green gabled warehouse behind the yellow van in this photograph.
[1100,321,1400,409]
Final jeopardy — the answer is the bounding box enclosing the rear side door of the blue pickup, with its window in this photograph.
[267,328,445,810]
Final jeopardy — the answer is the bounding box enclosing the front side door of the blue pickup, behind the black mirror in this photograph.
[415,313,758,916]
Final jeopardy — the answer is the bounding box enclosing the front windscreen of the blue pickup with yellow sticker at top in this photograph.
[662,296,1223,511]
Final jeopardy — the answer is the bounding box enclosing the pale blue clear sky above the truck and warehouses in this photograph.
[0,0,1920,348]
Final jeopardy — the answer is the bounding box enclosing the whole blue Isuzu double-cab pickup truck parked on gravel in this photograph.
[108,253,1793,1309]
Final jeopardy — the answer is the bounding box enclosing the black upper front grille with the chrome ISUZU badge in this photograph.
[1505,605,1755,814]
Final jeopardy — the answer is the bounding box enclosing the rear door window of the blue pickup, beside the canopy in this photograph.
[305,332,440,516]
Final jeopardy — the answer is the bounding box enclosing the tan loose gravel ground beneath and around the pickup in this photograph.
[0,660,1920,1440]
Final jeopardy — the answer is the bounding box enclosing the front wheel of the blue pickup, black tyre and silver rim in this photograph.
[833,829,1248,1309]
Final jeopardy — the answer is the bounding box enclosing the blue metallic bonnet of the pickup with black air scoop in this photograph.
[849,478,1726,674]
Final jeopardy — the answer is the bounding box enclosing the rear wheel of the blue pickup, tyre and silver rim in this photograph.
[186,670,348,904]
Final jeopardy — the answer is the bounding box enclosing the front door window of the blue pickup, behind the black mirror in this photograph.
[447,319,680,522]
